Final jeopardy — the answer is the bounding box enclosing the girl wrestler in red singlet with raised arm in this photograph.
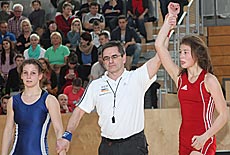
[155,3,228,155]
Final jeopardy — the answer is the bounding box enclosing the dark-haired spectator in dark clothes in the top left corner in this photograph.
[0,1,11,22]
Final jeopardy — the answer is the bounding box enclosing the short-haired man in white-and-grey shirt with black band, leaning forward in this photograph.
[82,2,105,32]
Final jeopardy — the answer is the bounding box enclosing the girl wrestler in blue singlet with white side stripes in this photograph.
[2,59,65,155]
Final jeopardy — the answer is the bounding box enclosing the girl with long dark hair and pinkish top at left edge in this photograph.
[0,39,16,80]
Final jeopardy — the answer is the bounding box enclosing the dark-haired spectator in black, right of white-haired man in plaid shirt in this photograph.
[28,0,45,31]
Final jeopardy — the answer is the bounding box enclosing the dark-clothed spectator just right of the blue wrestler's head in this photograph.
[39,58,58,96]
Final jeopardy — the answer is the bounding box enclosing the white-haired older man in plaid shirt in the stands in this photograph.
[8,4,26,38]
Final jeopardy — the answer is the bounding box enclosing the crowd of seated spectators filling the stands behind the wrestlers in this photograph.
[0,0,161,114]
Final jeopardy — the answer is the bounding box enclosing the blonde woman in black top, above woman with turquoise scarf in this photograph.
[16,19,33,54]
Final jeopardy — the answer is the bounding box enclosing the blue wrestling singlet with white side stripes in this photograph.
[10,91,51,155]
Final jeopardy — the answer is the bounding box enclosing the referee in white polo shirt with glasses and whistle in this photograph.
[57,41,161,155]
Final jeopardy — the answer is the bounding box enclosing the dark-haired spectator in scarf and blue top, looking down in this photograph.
[76,32,98,86]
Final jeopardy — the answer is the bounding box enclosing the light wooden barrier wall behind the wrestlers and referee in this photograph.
[0,108,230,155]
